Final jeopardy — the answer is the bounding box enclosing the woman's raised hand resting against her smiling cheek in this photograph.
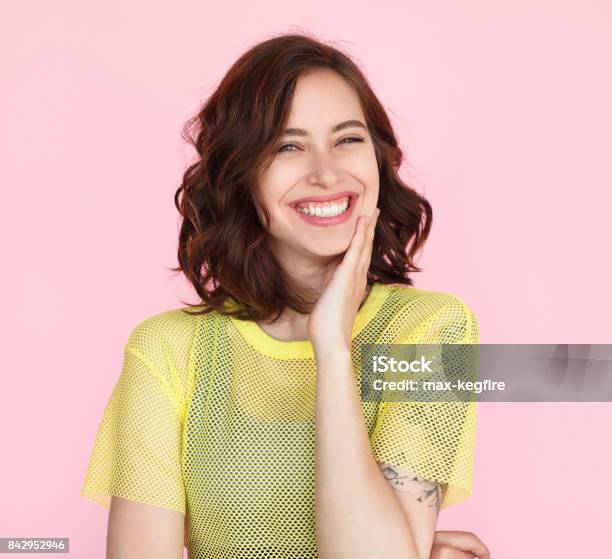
[308,208,380,350]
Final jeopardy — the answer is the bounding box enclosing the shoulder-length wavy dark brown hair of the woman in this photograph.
[170,33,432,321]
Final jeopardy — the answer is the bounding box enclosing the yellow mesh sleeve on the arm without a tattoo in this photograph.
[80,316,194,513]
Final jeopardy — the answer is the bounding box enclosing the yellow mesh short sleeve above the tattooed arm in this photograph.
[370,298,479,508]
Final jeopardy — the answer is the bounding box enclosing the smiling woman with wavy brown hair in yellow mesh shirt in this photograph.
[81,29,486,559]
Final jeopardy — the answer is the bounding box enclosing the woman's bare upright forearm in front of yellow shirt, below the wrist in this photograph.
[315,344,420,559]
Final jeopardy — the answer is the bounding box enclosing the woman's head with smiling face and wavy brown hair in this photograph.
[167,35,432,322]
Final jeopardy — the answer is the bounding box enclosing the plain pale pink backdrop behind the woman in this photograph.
[0,0,612,559]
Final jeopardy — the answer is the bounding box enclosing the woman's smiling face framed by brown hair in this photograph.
[259,66,379,269]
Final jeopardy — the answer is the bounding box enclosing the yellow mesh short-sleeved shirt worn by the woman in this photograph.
[80,283,478,559]
